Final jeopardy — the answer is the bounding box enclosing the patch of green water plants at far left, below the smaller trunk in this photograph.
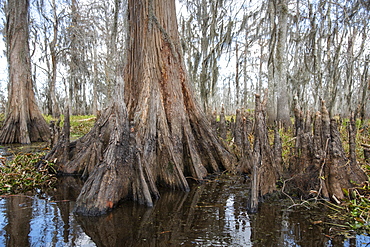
[0,152,56,195]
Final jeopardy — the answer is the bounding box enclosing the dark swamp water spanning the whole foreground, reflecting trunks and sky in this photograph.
[0,177,370,247]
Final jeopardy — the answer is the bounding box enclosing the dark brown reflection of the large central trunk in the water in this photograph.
[78,177,251,246]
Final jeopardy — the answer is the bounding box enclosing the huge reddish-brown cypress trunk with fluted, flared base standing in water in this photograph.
[47,0,234,215]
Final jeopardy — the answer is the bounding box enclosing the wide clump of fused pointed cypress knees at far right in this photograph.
[288,101,367,201]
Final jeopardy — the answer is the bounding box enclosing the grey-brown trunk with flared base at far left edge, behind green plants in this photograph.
[0,0,50,144]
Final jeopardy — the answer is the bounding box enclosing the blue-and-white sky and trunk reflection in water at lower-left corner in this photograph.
[0,196,95,246]
